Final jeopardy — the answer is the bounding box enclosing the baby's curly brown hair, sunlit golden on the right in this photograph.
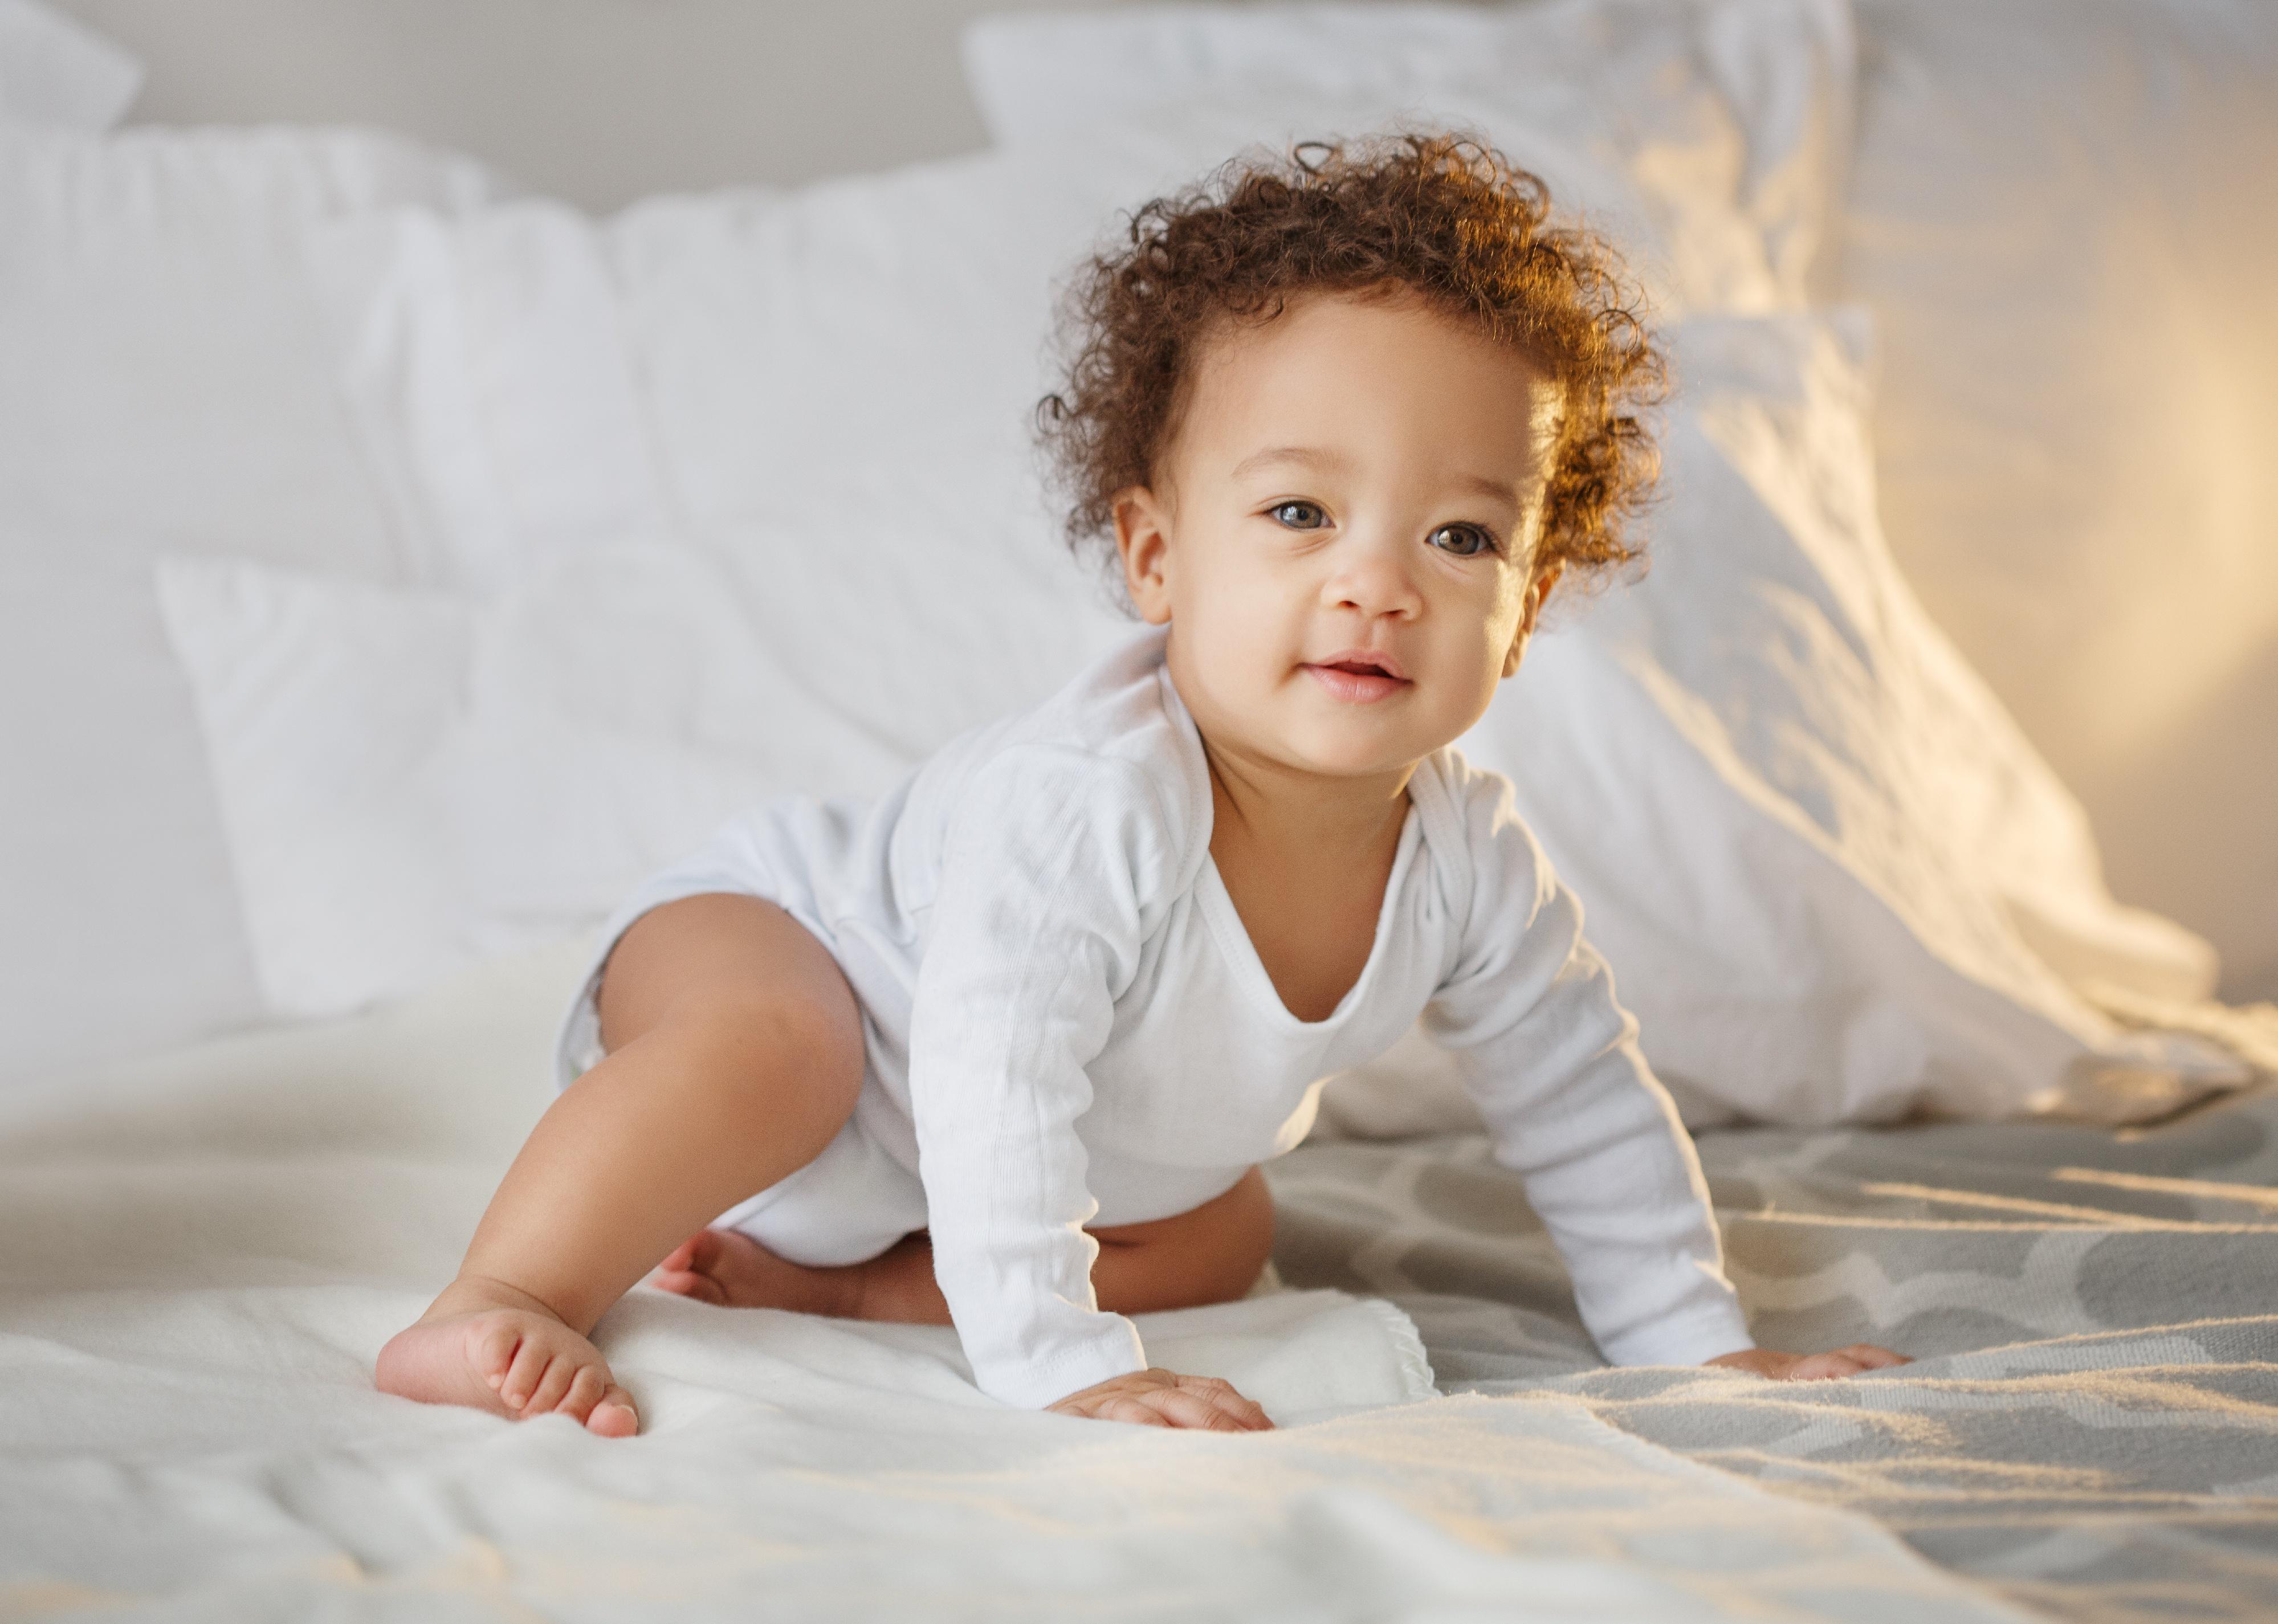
[1037,132,1668,578]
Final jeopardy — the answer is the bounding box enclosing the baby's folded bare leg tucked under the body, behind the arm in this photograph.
[651,1169,1273,1325]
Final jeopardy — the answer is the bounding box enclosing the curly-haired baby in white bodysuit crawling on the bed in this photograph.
[378,137,1900,1437]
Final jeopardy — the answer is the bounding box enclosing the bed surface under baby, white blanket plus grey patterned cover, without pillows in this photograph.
[0,939,2278,1622]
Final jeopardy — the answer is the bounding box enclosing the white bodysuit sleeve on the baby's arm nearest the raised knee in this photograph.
[909,745,1171,1407]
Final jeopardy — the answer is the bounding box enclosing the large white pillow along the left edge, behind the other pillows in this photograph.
[0,130,490,1080]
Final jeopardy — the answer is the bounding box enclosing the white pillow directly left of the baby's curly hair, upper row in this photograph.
[319,142,1189,583]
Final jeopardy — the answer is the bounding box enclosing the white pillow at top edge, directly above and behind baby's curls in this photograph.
[964,0,1857,310]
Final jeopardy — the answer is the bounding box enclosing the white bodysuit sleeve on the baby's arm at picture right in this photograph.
[1424,768,1754,1364]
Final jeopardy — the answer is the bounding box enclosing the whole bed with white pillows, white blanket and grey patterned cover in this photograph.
[0,0,2278,1624]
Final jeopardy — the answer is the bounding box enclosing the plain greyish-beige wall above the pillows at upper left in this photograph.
[52,0,1107,210]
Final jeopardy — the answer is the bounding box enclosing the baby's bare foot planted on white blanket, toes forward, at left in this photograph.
[374,1280,640,1437]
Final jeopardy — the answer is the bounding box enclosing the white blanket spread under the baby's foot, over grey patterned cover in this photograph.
[0,943,2014,1619]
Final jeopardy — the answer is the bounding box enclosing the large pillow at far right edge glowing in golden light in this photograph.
[1843,0,2278,998]
